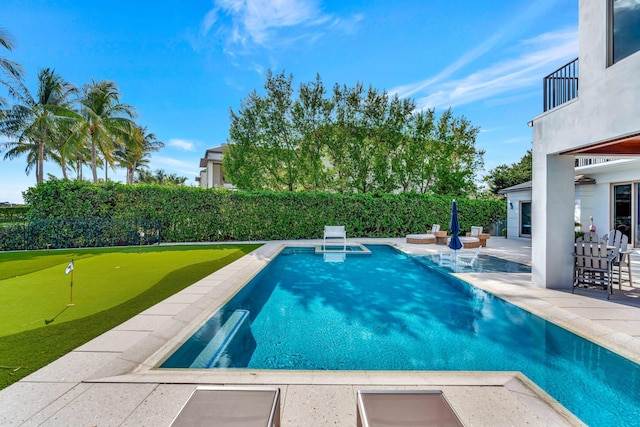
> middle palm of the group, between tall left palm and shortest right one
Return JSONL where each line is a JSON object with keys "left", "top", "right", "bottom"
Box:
{"left": 79, "top": 80, "right": 135, "bottom": 182}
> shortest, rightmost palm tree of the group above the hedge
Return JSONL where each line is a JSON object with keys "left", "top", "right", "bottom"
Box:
{"left": 116, "top": 125, "right": 164, "bottom": 184}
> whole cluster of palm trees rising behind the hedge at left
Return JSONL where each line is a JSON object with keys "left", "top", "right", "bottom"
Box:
{"left": 0, "top": 29, "right": 168, "bottom": 184}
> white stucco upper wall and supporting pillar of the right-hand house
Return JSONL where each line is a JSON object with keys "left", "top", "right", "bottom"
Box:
{"left": 532, "top": 0, "right": 640, "bottom": 288}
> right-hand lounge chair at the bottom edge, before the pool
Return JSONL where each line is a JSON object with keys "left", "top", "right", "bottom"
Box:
{"left": 357, "top": 390, "right": 463, "bottom": 427}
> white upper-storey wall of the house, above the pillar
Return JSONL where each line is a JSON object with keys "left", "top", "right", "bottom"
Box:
{"left": 534, "top": 0, "right": 640, "bottom": 153}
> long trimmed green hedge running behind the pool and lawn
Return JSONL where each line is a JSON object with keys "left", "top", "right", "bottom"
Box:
{"left": 18, "top": 180, "right": 506, "bottom": 246}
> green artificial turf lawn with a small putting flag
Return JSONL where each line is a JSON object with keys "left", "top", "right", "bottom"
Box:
{"left": 0, "top": 245, "right": 259, "bottom": 389}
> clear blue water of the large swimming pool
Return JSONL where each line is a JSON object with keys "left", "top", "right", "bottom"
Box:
{"left": 162, "top": 246, "right": 640, "bottom": 426}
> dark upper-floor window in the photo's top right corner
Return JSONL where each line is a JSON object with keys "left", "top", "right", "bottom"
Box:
{"left": 609, "top": 0, "right": 640, "bottom": 65}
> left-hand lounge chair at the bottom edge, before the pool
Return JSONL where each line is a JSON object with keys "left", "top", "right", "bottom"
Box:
{"left": 171, "top": 386, "right": 280, "bottom": 427}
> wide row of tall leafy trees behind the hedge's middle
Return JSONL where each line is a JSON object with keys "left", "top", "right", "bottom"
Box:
{"left": 223, "top": 71, "right": 484, "bottom": 196}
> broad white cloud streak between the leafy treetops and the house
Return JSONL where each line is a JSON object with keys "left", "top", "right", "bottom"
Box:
{"left": 394, "top": 27, "right": 578, "bottom": 109}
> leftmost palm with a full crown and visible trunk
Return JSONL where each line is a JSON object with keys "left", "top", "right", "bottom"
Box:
{"left": 0, "top": 68, "right": 78, "bottom": 184}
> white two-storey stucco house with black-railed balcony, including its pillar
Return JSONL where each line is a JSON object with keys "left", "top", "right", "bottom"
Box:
{"left": 531, "top": 0, "right": 640, "bottom": 288}
